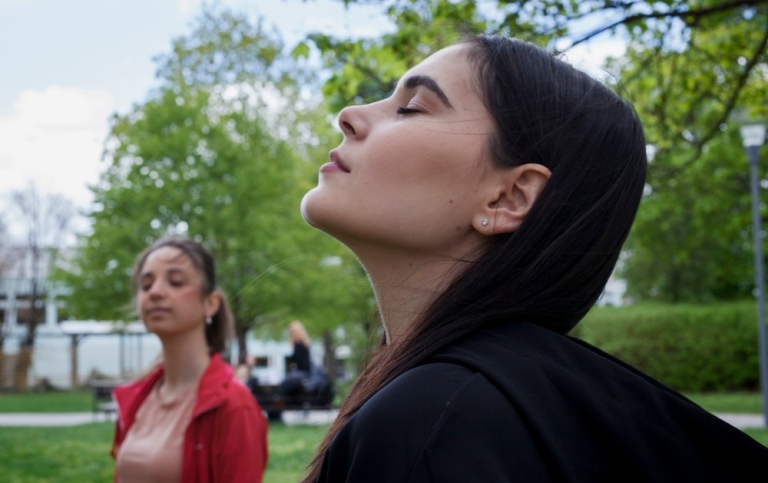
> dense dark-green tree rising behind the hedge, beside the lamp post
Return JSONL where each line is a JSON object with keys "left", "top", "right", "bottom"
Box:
{"left": 622, "top": 128, "right": 754, "bottom": 302}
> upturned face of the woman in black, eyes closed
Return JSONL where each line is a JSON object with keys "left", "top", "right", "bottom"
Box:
{"left": 302, "top": 45, "right": 494, "bottom": 260}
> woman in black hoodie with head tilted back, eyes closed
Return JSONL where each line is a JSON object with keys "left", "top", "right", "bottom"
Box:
{"left": 302, "top": 36, "right": 768, "bottom": 483}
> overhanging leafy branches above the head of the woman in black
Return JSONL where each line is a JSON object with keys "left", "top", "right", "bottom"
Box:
{"left": 320, "top": 0, "right": 768, "bottom": 132}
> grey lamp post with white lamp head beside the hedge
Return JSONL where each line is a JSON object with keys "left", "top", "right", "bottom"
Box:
{"left": 741, "top": 124, "right": 768, "bottom": 425}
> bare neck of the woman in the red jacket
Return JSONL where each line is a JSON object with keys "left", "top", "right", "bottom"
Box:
{"left": 162, "top": 332, "right": 211, "bottom": 391}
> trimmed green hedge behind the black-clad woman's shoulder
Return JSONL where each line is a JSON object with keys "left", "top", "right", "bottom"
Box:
{"left": 571, "top": 301, "right": 759, "bottom": 392}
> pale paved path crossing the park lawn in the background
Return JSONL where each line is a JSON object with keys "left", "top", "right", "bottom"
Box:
{"left": 0, "top": 410, "right": 765, "bottom": 429}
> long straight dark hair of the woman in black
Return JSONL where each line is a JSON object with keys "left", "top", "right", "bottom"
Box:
{"left": 303, "top": 36, "right": 647, "bottom": 482}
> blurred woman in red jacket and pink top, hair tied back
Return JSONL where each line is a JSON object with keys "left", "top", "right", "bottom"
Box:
{"left": 112, "top": 237, "right": 267, "bottom": 483}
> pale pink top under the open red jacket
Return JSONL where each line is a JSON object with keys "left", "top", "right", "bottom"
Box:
{"left": 115, "top": 381, "right": 197, "bottom": 483}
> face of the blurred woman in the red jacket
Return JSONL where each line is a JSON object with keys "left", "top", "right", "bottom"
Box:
{"left": 137, "top": 247, "right": 213, "bottom": 336}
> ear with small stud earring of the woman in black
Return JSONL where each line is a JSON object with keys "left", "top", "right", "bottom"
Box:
{"left": 472, "top": 163, "right": 552, "bottom": 235}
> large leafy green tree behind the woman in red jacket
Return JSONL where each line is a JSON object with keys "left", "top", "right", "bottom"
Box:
{"left": 60, "top": 5, "right": 367, "bottom": 362}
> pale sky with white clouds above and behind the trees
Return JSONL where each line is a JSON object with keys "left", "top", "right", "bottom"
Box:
{"left": 0, "top": 0, "right": 616, "bottom": 236}
